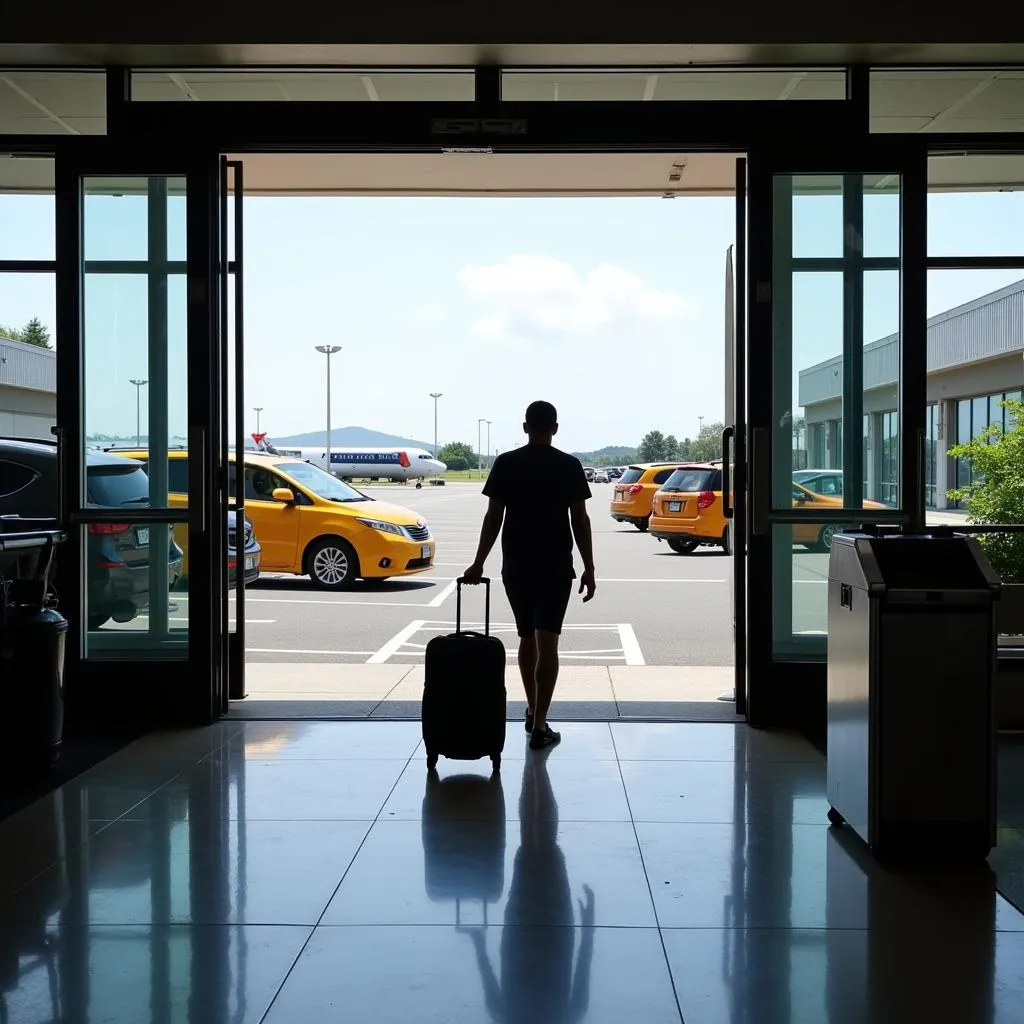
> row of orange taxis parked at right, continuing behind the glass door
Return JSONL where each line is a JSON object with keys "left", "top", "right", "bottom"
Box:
{"left": 610, "top": 461, "right": 886, "bottom": 555}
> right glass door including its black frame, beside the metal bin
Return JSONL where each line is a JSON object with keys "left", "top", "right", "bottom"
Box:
{"left": 748, "top": 148, "right": 925, "bottom": 720}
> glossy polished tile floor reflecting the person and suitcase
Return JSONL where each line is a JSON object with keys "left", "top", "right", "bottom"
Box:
{"left": 0, "top": 722, "right": 1024, "bottom": 1024}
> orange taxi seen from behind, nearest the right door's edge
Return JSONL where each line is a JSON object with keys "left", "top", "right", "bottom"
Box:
{"left": 650, "top": 463, "right": 729, "bottom": 555}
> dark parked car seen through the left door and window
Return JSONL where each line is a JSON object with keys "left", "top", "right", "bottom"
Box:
{"left": 0, "top": 438, "right": 181, "bottom": 630}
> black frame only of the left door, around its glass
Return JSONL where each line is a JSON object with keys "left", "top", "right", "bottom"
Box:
{"left": 55, "top": 138, "right": 226, "bottom": 727}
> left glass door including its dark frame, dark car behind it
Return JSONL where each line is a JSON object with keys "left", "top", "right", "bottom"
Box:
{"left": 57, "top": 155, "right": 222, "bottom": 721}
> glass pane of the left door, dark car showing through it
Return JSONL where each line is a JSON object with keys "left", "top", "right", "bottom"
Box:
{"left": 74, "top": 175, "right": 189, "bottom": 659}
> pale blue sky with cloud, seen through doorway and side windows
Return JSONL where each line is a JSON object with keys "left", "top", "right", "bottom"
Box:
{"left": 0, "top": 193, "right": 1024, "bottom": 450}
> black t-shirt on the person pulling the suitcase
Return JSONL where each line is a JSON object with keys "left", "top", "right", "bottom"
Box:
{"left": 483, "top": 444, "right": 590, "bottom": 580}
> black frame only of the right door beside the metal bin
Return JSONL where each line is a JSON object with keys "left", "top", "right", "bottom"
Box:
{"left": 737, "top": 136, "right": 928, "bottom": 735}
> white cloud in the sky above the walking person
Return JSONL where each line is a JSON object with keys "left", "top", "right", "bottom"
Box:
{"left": 459, "top": 255, "right": 693, "bottom": 338}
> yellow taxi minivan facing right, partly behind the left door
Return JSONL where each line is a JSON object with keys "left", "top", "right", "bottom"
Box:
{"left": 111, "top": 450, "right": 434, "bottom": 590}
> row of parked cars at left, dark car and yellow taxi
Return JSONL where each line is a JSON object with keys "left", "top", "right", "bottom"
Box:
{"left": 0, "top": 437, "right": 434, "bottom": 630}
